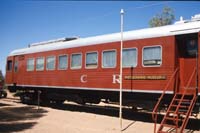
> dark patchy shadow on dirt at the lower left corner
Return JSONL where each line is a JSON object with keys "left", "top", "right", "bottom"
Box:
{"left": 0, "top": 106, "right": 47, "bottom": 133}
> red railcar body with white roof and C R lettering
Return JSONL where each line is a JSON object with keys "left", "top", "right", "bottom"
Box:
{"left": 6, "top": 15, "right": 200, "bottom": 109}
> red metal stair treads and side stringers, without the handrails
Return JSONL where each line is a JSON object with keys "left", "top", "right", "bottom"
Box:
{"left": 157, "top": 93, "right": 196, "bottom": 133}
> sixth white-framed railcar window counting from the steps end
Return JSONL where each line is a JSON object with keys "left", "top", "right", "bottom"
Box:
{"left": 58, "top": 55, "right": 68, "bottom": 70}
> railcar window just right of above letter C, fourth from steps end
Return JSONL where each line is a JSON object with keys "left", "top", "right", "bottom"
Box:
{"left": 86, "top": 52, "right": 98, "bottom": 68}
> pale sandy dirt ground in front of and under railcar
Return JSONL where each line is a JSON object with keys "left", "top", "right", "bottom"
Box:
{"left": 0, "top": 92, "right": 200, "bottom": 133}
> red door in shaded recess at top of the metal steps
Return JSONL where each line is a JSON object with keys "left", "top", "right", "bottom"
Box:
{"left": 176, "top": 33, "right": 198, "bottom": 93}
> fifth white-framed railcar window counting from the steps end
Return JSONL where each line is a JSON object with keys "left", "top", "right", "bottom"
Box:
{"left": 71, "top": 54, "right": 82, "bottom": 69}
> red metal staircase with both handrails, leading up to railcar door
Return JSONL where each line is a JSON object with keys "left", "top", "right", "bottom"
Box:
{"left": 152, "top": 68, "right": 197, "bottom": 133}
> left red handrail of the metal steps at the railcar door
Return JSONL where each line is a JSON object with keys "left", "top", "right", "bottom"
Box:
{"left": 152, "top": 68, "right": 179, "bottom": 133}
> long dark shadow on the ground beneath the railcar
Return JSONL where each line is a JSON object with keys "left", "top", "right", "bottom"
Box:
{"left": 48, "top": 104, "right": 200, "bottom": 133}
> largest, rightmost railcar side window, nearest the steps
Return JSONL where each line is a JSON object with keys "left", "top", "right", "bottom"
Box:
{"left": 143, "top": 46, "right": 162, "bottom": 66}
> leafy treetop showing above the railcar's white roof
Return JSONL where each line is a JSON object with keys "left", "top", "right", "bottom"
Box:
{"left": 149, "top": 7, "right": 175, "bottom": 27}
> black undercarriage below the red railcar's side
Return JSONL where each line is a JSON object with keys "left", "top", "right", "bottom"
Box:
{"left": 9, "top": 87, "right": 200, "bottom": 114}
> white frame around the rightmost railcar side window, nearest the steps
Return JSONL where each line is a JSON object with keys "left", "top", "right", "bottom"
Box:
{"left": 142, "top": 45, "right": 163, "bottom": 67}
